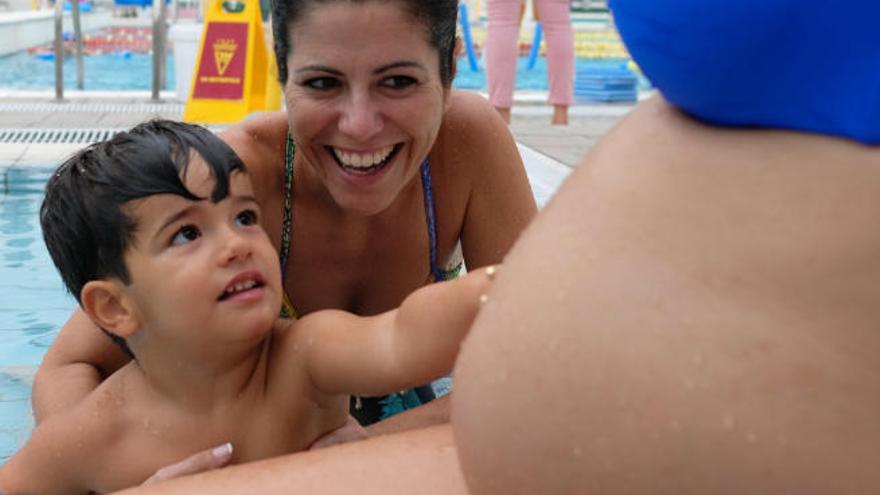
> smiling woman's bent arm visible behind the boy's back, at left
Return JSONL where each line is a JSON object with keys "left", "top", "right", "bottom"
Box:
{"left": 31, "top": 308, "right": 129, "bottom": 424}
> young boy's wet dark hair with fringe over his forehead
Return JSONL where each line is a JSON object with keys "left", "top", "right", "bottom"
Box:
{"left": 40, "top": 120, "right": 245, "bottom": 355}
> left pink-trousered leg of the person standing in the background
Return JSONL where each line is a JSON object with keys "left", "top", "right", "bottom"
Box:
{"left": 486, "top": 0, "right": 520, "bottom": 123}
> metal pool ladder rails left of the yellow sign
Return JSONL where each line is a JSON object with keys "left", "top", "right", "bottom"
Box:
{"left": 55, "top": 0, "right": 168, "bottom": 101}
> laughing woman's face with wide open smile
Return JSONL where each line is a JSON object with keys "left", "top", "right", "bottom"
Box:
{"left": 285, "top": 2, "right": 448, "bottom": 215}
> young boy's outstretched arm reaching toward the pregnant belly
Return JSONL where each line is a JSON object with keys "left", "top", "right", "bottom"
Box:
{"left": 297, "top": 267, "right": 496, "bottom": 395}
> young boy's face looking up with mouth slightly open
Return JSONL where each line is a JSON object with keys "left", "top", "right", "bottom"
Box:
{"left": 124, "top": 154, "right": 282, "bottom": 353}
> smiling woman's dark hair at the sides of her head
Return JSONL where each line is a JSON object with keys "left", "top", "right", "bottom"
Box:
{"left": 272, "top": 0, "right": 458, "bottom": 87}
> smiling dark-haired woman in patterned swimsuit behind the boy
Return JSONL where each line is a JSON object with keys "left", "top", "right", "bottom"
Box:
{"left": 34, "top": 0, "right": 536, "bottom": 484}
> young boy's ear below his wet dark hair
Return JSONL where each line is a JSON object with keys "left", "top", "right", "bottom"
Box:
{"left": 80, "top": 280, "right": 141, "bottom": 339}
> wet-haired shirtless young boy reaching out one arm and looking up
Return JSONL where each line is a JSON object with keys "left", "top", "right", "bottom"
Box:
{"left": 0, "top": 121, "right": 493, "bottom": 494}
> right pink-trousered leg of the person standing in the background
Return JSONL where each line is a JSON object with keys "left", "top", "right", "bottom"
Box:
{"left": 535, "top": 0, "right": 574, "bottom": 125}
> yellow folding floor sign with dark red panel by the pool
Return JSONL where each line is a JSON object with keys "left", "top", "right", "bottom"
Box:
{"left": 183, "top": 0, "right": 281, "bottom": 124}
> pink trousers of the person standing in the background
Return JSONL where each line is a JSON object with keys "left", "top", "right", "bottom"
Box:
{"left": 486, "top": 0, "right": 574, "bottom": 108}
